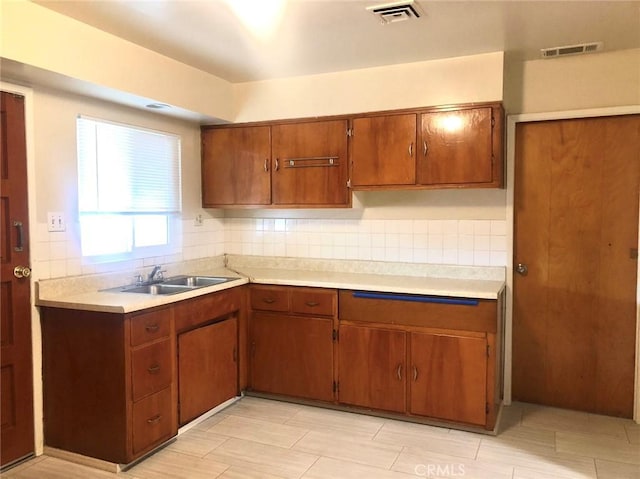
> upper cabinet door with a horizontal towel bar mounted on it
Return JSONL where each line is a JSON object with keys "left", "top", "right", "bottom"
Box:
{"left": 271, "top": 120, "right": 350, "bottom": 206}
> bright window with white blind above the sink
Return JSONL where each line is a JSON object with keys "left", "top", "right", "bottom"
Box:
{"left": 77, "top": 117, "right": 182, "bottom": 262}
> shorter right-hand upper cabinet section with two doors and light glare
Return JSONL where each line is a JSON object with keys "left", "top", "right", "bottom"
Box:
{"left": 351, "top": 103, "right": 504, "bottom": 190}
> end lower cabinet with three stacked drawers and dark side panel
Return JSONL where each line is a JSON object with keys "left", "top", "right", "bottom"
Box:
{"left": 41, "top": 308, "right": 178, "bottom": 464}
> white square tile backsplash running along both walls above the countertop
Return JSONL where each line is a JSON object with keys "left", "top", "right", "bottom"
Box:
{"left": 31, "top": 218, "right": 507, "bottom": 279}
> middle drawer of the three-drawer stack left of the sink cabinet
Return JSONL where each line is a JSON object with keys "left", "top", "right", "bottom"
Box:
{"left": 131, "top": 339, "right": 172, "bottom": 401}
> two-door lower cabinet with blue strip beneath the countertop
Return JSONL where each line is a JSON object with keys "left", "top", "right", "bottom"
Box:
{"left": 337, "top": 290, "right": 502, "bottom": 429}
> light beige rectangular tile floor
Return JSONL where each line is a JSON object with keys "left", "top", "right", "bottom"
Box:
{"left": 2, "top": 397, "right": 640, "bottom": 479}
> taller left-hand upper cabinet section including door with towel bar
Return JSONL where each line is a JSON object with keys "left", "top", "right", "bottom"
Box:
{"left": 202, "top": 119, "right": 351, "bottom": 208}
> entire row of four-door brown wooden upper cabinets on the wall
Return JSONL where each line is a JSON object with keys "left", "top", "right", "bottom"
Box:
{"left": 202, "top": 102, "right": 504, "bottom": 208}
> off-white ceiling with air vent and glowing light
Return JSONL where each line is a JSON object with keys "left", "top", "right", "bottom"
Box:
{"left": 36, "top": 0, "right": 640, "bottom": 82}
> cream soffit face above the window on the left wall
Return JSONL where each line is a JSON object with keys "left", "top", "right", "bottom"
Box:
{"left": 0, "top": 0, "right": 233, "bottom": 120}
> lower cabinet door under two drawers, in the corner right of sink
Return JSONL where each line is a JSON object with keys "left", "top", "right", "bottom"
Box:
{"left": 249, "top": 313, "right": 333, "bottom": 401}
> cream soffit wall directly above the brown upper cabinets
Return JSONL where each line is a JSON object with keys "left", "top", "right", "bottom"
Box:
{"left": 234, "top": 52, "right": 503, "bottom": 122}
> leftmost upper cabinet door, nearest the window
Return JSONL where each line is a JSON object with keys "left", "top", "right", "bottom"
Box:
{"left": 202, "top": 126, "right": 271, "bottom": 207}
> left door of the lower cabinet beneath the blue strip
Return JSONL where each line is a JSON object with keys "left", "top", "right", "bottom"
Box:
{"left": 338, "top": 325, "right": 406, "bottom": 412}
